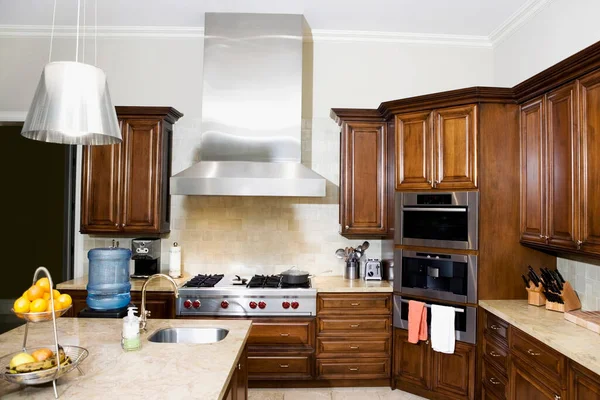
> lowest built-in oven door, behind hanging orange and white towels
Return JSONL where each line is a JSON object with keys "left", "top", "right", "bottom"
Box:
{"left": 394, "top": 295, "right": 477, "bottom": 344}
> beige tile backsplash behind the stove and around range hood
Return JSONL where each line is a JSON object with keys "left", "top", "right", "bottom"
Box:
{"left": 83, "top": 118, "right": 381, "bottom": 275}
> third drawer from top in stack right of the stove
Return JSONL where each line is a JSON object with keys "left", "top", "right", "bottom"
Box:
{"left": 317, "top": 337, "right": 390, "bottom": 357}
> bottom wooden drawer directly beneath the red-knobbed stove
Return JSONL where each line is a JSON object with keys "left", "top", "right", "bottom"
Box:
{"left": 247, "top": 354, "right": 312, "bottom": 379}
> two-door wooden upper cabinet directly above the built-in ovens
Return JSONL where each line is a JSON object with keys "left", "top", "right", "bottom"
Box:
{"left": 395, "top": 105, "right": 477, "bottom": 190}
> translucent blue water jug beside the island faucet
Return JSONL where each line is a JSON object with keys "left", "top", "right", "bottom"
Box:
{"left": 85, "top": 247, "right": 131, "bottom": 310}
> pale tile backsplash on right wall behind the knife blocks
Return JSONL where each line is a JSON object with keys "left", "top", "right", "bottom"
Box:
{"left": 556, "top": 258, "right": 600, "bottom": 311}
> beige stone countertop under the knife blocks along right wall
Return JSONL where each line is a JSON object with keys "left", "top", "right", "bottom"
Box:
{"left": 479, "top": 300, "right": 600, "bottom": 374}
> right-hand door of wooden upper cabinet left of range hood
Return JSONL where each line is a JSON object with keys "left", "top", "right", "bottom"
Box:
{"left": 123, "top": 119, "right": 162, "bottom": 232}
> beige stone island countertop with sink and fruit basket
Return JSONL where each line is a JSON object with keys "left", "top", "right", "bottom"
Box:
{"left": 0, "top": 318, "right": 252, "bottom": 400}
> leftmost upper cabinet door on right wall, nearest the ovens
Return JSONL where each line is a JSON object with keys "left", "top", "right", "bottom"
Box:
{"left": 521, "top": 97, "right": 546, "bottom": 243}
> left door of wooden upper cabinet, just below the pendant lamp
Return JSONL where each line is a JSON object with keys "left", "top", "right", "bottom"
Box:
{"left": 81, "top": 138, "right": 122, "bottom": 233}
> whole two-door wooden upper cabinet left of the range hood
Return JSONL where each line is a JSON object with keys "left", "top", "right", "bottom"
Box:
{"left": 81, "top": 107, "right": 183, "bottom": 234}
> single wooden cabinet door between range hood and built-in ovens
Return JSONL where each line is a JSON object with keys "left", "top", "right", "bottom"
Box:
{"left": 340, "top": 121, "right": 389, "bottom": 237}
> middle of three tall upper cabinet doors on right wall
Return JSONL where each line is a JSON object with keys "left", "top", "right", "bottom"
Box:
{"left": 546, "top": 84, "right": 578, "bottom": 248}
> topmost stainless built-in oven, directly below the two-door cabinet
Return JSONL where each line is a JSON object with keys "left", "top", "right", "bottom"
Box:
{"left": 396, "top": 192, "right": 479, "bottom": 250}
